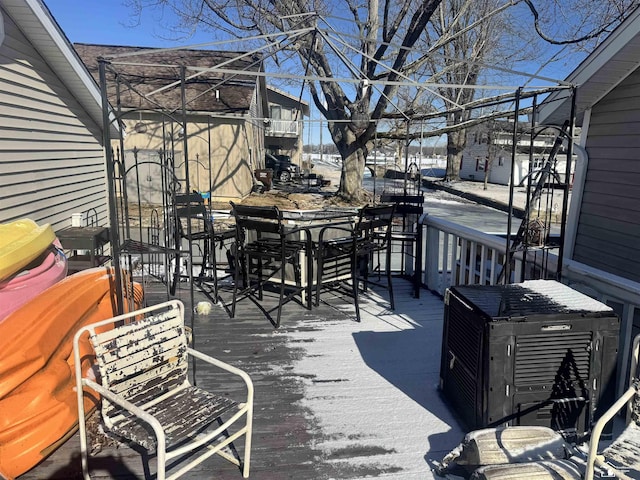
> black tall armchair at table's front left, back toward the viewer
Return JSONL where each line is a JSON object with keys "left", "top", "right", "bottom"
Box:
{"left": 230, "top": 202, "right": 313, "bottom": 328}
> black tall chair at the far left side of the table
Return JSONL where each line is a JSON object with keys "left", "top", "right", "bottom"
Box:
{"left": 170, "top": 192, "right": 235, "bottom": 301}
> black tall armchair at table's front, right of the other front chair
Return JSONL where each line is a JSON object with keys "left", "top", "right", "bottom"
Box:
{"left": 315, "top": 205, "right": 395, "bottom": 321}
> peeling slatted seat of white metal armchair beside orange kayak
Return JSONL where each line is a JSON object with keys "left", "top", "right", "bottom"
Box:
{"left": 111, "top": 386, "right": 238, "bottom": 451}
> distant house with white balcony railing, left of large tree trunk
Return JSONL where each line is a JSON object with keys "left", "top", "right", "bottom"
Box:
{"left": 265, "top": 87, "right": 309, "bottom": 169}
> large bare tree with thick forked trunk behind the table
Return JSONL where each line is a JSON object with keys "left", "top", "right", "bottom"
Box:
{"left": 129, "top": 0, "right": 441, "bottom": 201}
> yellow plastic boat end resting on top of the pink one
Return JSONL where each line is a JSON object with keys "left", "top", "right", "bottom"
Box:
{"left": 0, "top": 218, "right": 56, "bottom": 281}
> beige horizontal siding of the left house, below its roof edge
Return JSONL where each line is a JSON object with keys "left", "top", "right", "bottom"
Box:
{"left": 0, "top": 11, "right": 108, "bottom": 231}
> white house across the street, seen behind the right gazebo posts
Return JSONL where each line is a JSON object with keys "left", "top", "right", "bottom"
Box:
{"left": 460, "top": 121, "right": 567, "bottom": 186}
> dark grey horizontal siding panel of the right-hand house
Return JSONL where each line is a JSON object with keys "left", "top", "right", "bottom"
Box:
{"left": 573, "top": 63, "right": 640, "bottom": 282}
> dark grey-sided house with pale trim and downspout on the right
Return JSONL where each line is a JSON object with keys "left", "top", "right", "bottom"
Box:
{"left": 540, "top": 2, "right": 640, "bottom": 378}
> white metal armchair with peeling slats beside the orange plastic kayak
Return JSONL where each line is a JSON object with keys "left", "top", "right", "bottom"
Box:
{"left": 74, "top": 300, "right": 253, "bottom": 480}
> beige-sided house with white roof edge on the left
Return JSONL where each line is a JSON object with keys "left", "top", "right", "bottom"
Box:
{"left": 0, "top": 0, "right": 115, "bottom": 231}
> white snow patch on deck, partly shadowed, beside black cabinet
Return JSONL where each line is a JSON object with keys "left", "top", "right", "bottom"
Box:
{"left": 276, "top": 279, "right": 463, "bottom": 480}
